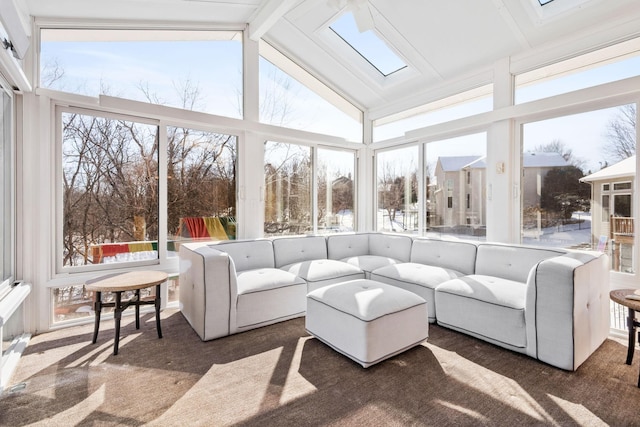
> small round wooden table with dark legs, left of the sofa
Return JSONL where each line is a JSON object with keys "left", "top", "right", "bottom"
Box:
{"left": 85, "top": 271, "right": 169, "bottom": 356}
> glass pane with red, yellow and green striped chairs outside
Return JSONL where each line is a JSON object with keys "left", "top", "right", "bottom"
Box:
{"left": 167, "top": 127, "right": 237, "bottom": 256}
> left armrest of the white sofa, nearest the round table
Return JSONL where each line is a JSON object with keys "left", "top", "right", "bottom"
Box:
{"left": 179, "top": 244, "right": 237, "bottom": 341}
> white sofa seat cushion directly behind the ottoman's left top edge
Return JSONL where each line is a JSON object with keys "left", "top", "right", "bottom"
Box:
{"left": 280, "top": 259, "right": 364, "bottom": 292}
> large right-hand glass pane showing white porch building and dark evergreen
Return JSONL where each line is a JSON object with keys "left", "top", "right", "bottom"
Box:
{"left": 522, "top": 105, "right": 635, "bottom": 272}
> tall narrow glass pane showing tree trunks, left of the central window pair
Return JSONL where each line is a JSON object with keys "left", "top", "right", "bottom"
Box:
{"left": 264, "top": 141, "right": 312, "bottom": 236}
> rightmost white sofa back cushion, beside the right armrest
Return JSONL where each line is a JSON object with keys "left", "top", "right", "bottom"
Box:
{"left": 476, "top": 243, "right": 566, "bottom": 283}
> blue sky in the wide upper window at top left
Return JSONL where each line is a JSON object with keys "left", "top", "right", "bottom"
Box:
{"left": 41, "top": 41, "right": 242, "bottom": 118}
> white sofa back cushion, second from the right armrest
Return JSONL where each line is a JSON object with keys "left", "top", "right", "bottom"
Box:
{"left": 411, "top": 239, "right": 477, "bottom": 274}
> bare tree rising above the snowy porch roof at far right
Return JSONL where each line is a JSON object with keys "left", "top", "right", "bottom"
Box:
{"left": 602, "top": 104, "right": 637, "bottom": 163}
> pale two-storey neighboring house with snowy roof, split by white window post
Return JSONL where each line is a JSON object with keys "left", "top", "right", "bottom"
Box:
{"left": 436, "top": 153, "right": 569, "bottom": 227}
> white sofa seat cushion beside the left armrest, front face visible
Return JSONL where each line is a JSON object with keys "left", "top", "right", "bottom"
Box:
{"left": 236, "top": 268, "right": 307, "bottom": 330}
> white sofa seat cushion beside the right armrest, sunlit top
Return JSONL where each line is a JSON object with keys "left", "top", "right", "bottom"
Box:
{"left": 435, "top": 275, "right": 527, "bottom": 351}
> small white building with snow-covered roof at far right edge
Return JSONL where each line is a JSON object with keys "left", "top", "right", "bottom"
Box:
{"left": 580, "top": 156, "right": 636, "bottom": 251}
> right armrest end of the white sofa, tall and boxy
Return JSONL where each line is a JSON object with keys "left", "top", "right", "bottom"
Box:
{"left": 525, "top": 252, "right": 609, "bottom": 371}
